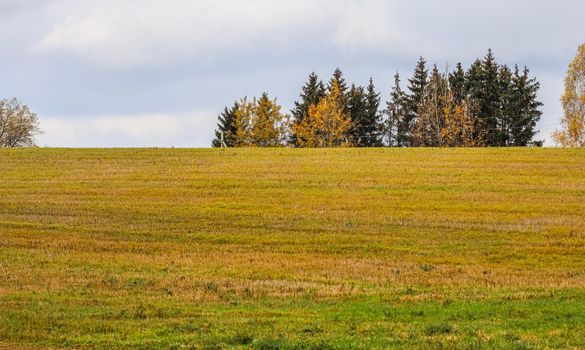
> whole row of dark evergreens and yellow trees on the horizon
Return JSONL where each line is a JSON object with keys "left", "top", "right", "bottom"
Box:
{"left": 212, "top": 50, "right": 542, "bottom": 147}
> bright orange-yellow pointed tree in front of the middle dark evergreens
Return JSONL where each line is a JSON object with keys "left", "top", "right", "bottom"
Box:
{"left": 292, "top": 80, "right": 352, "bottom": 148}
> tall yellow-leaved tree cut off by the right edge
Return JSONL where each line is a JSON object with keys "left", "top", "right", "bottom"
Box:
{"left": 552, "top": 44, "right": 585, "bottom": 147}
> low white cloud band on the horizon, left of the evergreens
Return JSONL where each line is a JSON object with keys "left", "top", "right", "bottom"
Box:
{"left": 39, "top": 112, "right": 215, "bottom": 147}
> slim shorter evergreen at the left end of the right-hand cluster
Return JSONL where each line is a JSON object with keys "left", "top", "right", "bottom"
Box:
{"left": 384, "top": 73, "right": 409, "bottom": 147}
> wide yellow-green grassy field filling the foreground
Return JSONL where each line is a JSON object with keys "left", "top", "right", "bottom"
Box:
{"left": 0, "top": 149, "right": 585, "bottom": 349}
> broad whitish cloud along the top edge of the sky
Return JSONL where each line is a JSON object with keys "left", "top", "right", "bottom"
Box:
{"left": 33, "top": 0, "right": 342, "bottom": 67}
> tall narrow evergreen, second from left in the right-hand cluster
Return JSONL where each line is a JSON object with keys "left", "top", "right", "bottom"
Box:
{"left": 404, "top": 57, "right": 428, "bottom": 146}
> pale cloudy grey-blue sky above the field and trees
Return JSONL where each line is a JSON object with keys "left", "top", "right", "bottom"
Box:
{"left": 0, "top": 0, "right": 585, "bottom": 147}
